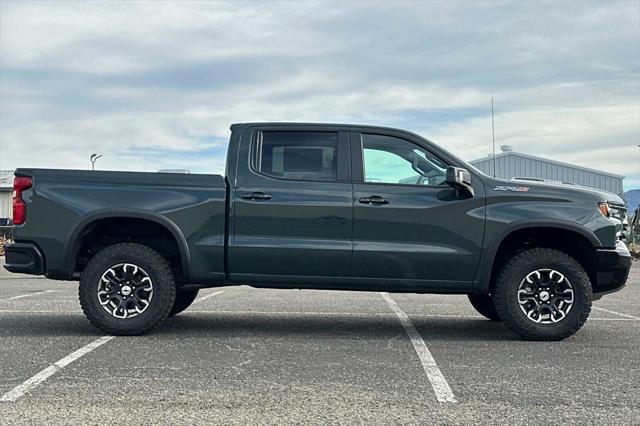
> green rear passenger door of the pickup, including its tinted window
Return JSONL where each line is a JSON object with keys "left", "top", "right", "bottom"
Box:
{"left": 229, "top": 126, "right": 353, "bottom": 281}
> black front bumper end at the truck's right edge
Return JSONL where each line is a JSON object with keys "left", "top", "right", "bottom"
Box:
{"left": 593, "top": 241, "right": 631, "bottom": 299}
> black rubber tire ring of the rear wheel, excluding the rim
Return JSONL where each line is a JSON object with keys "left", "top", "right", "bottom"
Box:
{"left": 79, "top": 243, "right": 176, "bottom": 336}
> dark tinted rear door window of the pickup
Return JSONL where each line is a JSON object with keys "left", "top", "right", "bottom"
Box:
{"left": 253, "top": 131, "right": 338, "bottom": 181}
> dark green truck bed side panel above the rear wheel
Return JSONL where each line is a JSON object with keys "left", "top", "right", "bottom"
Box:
{"left": 11, "top": 169, "right": 227, "bottom": 282}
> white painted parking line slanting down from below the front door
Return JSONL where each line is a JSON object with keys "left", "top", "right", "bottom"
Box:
{"left": 380, "top": 293, "right": 457, "bottom": 402}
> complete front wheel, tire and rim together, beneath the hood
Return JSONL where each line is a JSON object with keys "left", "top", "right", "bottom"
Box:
{"left": 493, "top": 248, "right": 593, "bottom": 340}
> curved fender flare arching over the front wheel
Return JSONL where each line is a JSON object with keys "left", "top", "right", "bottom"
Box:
{"left": 476, "top": 219, "right": 602, "bottom": 294}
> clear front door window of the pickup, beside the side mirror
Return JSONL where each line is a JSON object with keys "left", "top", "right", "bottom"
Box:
{"left": 362, "top": 133, "right": 447, "bottom": 186}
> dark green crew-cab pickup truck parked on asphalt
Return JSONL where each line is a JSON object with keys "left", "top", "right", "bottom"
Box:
{"left": 5, "top": 123, "right": 631, "bottom": 340}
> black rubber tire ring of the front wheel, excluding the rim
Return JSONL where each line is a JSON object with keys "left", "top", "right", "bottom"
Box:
{"left": 493, "top": 248, "right": 593, "bottom": 341}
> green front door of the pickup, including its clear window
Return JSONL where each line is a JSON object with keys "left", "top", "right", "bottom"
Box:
{"left": 351, "top": 131, "right": 484, "bottom": 290}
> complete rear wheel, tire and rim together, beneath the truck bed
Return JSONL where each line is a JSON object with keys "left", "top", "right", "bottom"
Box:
{"left": 79, "top": 243, "right": 176, "bottom": 335}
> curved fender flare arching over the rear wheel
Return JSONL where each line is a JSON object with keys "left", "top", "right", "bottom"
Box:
{"left": 63, "top": 208, "right": 191, "bottom": 280}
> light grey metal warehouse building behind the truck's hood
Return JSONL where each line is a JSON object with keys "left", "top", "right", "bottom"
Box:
{"left": 470, "top": 145, "right": 624, "bottom": 195}
